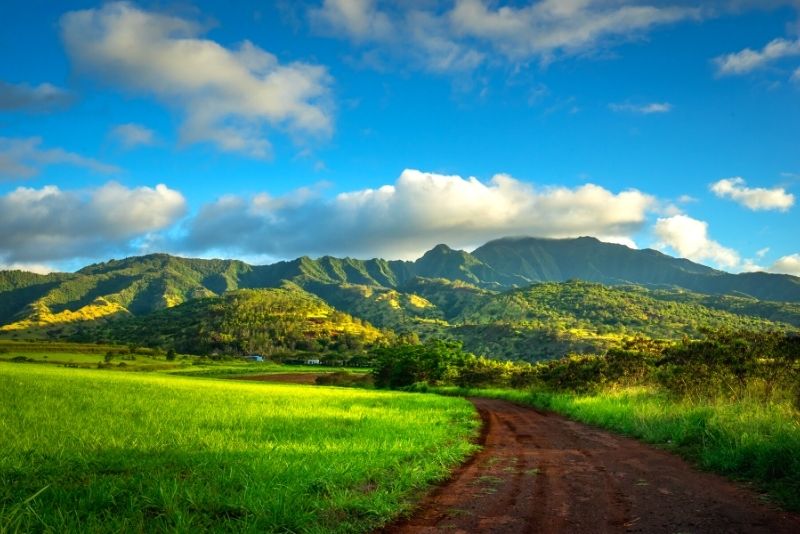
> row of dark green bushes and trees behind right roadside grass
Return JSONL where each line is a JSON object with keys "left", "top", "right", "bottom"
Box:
{"left": 373, "top": 330, "right": 800, "bottom": 408}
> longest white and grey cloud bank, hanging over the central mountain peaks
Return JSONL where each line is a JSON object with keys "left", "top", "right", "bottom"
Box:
{"left": 183, "top": 170, "right": 656, "bottom": 258}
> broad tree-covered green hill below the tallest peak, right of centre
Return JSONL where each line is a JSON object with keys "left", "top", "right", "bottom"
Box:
{"left": 451, "top": 281, "right": 800, "bottom": 361}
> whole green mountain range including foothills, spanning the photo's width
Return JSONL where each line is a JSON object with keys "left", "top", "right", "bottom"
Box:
{"left": 0, "top": 237, "right": 800, "bottom": 359}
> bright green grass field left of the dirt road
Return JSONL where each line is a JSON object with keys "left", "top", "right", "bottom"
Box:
{"left": 0, "top": 362, "right": 478, "bottom": 532}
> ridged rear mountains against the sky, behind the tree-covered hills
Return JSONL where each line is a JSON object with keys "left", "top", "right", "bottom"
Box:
{"left": 0, "top": 237, "right": 800, "bottom": 330}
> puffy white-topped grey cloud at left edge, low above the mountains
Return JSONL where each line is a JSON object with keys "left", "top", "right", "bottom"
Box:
{"left": 0, "top": 182, "right": 186, "bottom": 265}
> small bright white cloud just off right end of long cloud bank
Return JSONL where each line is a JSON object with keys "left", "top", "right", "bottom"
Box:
{"left": 654, "top": 215, "right": 740, "bottom": 268}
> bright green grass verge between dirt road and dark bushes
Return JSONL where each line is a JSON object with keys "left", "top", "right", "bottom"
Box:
{"left": 430, "top": 386, "right": 800, "bottom": 511}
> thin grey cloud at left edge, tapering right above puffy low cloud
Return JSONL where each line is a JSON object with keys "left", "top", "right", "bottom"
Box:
{"left": 0, "top": 137, "right": 120, "bottom": 181}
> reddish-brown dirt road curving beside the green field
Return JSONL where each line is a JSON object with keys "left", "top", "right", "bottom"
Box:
{"left": 384, "top": 398, "right": 800, "bottom": 534}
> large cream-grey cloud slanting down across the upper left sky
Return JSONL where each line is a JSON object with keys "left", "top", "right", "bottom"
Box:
{"left": 61, "top": 2, "right": 332, "bottom": 158}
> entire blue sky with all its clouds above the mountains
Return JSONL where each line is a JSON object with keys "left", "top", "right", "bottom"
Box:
{"left": 0, "top": 0, "right": 800, "bottom": 275}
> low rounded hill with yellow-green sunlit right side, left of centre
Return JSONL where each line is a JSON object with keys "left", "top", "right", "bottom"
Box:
{"left": 86, "top": 288, "right": 391, "bottom": 355}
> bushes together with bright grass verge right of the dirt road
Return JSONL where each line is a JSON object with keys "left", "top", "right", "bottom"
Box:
{"left": 374, "top": 331, "right": 800, "bottom": 510}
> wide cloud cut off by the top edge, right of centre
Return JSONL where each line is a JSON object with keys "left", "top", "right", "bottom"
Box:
{"left": 309, "top": 0, "right": 701, "bottom": 71}
